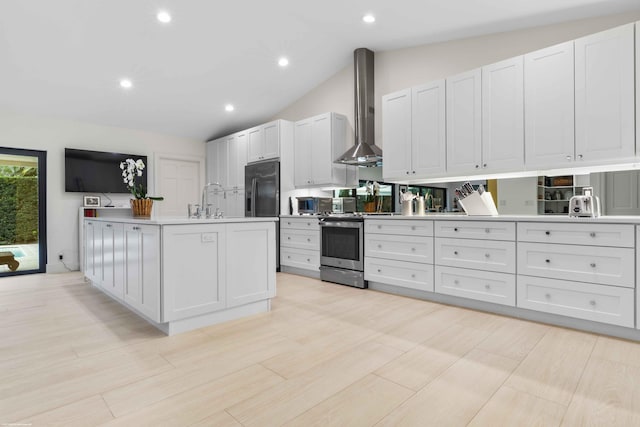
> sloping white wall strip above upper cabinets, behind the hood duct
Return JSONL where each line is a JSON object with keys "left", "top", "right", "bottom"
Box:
{"left": 274, "top": 9, "right": 640, "bottom": 156}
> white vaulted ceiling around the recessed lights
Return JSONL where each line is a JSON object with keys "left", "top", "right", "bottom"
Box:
{"left": 0, "top": 0, "right": 639, "bottom": 140}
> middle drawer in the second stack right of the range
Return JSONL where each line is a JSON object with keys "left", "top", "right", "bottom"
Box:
{"left": 435, "top": 238, "right": 516, "bottom": 273}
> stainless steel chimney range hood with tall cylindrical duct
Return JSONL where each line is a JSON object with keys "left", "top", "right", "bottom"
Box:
{"left": 335, "top": 48, "right": 382, "bottom": 167}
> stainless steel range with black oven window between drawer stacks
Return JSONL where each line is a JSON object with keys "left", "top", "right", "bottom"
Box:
{"left": 320, "top": 214, "right": 367, "bottom": 288}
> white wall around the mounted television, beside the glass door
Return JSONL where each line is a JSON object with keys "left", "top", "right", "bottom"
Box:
{"left": 0, "top": 111, "right": 205, "bottom": 272}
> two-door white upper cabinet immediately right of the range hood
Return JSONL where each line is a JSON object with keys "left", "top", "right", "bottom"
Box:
{"left": 382, "top": 80, "right": 446, "bottom": 180}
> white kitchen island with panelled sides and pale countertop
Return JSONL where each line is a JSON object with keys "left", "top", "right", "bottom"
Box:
{"left": 82, "top": 217, "right": 278, "bottom": 335}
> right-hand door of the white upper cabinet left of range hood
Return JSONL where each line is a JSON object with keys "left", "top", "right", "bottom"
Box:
{"left": 309, "top": 113, "right": 336, "bottom": 185}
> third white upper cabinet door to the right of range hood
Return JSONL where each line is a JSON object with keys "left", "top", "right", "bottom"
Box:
{"left": 447, "top": 69, "right": 482, "bottom": 174}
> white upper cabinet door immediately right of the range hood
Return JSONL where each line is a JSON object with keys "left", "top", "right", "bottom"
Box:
{"left": 382, "top": 89, "right": 412, "bottom": 179}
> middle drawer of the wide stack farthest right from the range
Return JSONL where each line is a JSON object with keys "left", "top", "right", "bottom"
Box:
{"left": 518, "top": 243, "right": 635, "bottom": 288}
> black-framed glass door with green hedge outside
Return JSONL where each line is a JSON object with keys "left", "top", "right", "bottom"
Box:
{"left": 0, "top": 147, "right": 47, "bottom": 277}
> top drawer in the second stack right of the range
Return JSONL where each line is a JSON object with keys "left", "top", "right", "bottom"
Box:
{"left": 435, "top": 220, "right": 516, "bottom": 240}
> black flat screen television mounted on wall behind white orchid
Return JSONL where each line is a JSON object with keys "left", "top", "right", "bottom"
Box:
{"left": 64, "top": 148, "right": 147, "bottom": 193}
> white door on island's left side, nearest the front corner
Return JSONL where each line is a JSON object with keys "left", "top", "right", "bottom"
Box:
{"left": 124, "top": 224, "right": 160, "bottom": 322}
